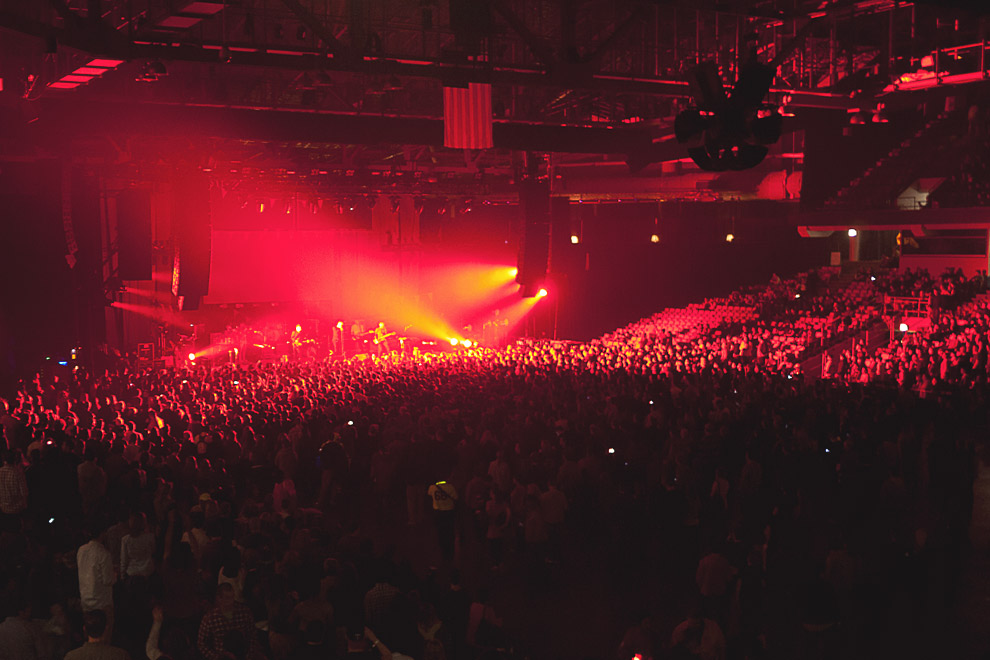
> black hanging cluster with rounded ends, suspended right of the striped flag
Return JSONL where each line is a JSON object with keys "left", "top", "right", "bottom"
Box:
{"left": 674, "top": 59, "right": 783, "bottom": 172}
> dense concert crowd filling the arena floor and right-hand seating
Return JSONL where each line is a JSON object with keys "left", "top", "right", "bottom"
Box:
{"left": 0, "top": 270, "right": 990, "bottom": 660}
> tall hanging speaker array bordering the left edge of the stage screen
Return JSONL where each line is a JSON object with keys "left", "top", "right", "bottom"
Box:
{"left": 172, "top": 177, "right": 212, "bottom": 299}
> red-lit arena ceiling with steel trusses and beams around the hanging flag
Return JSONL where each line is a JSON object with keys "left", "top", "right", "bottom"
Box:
{"left": 0, "top": 0, "right": 986, "bottom": 197}
